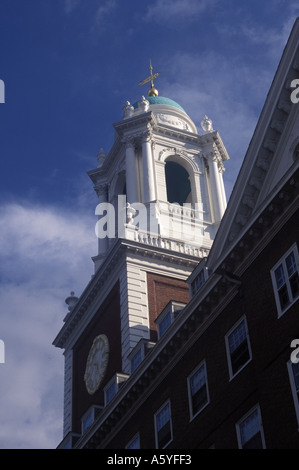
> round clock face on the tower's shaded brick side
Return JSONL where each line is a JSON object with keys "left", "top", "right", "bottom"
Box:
{"left": 84, "top": 335, "right": 109, "bottom": 395}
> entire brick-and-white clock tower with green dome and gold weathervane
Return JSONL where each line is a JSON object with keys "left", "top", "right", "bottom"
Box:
{"left": 54, "top": 64, "right": 229, "bottom": 442}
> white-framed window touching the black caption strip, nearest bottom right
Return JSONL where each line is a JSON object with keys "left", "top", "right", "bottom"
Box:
{"left": 237, "top": 407, "right": 265, "bottom": 449}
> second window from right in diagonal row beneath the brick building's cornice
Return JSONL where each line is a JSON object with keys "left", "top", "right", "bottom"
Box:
{"left": 225, "top": 318, "right": 251, "bottom": 378}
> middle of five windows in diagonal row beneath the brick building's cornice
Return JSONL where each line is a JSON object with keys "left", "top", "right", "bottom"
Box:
{"left": 187, "top": 363, "right": 209, "bottom": 419}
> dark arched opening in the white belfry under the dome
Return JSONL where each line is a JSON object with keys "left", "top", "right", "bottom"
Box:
{"left": 165, "top": 161, "right": 192, "bottom": 206}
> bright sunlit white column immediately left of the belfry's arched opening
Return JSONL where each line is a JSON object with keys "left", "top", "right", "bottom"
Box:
{"left": 142, "top": 132, "right": 156, "bottom": 203}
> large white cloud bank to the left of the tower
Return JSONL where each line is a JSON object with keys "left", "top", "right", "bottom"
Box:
{"left": 0, "top": 203, "right": 96, "bottom": 449}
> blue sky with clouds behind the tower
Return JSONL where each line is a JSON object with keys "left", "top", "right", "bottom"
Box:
{"left": 0, "top": 0, "right": 299, "bottom": 449}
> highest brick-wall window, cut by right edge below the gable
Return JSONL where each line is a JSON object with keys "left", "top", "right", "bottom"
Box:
{"left": 271, "top": 245, "right": 299, "bottom": 316}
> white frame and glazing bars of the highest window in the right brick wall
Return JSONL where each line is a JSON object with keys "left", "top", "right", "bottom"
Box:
{"left": 271, "top": 243, "right": 299, "bottom": 318}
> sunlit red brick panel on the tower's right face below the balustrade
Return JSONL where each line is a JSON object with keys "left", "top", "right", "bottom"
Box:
{"left": 147, "top": 273, "right": 189, "bottom": 341}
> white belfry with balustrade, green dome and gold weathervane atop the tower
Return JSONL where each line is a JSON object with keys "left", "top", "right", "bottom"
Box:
{"left": 89, "top": 65, "right": 229, "bottom": 269}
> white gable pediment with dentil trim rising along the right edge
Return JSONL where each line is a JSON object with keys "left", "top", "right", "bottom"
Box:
{"left": 207, "top": 18, "right": 299, "bottom": 271}
